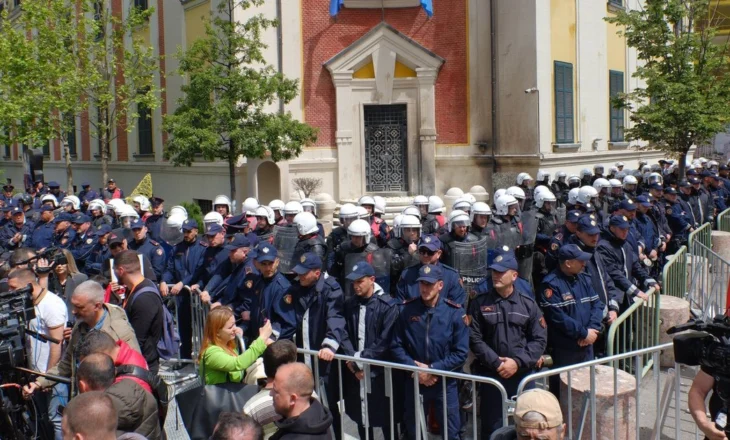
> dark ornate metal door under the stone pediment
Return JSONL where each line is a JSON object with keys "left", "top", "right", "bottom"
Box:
{"left": 365, "top": 104, "right": 408, "bottom": 192}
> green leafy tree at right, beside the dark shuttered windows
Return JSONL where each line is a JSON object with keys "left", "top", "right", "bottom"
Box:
{"left": 606, "top": 0, "right": 730, "bottom": 178}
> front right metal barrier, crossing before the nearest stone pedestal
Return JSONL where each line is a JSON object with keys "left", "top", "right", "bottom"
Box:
{"left": 510, "top": 343, "right": 699, "bottom": 440}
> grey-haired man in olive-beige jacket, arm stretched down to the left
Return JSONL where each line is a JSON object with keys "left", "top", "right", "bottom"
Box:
{"left": 23, "top": 281, "right": 140, "bottom": 397}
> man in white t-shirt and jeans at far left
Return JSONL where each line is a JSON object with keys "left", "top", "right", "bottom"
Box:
{"left": 8, "top": 268, "right": 68, "bottom": 439}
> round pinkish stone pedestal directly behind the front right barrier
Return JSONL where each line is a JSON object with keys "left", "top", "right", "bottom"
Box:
{"left": 560, "top": 365, "right": 637, "bottom": 440}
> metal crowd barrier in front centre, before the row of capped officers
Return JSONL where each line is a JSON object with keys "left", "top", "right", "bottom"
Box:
{"left": 297, "top": 348, "right": 510, "bottom": 440}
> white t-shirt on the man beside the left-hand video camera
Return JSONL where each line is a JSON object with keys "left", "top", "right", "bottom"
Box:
{"left": 26, "top": 292, "right": 68, "bottom": 373}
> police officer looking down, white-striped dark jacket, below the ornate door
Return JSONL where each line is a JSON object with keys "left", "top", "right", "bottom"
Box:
{"left": 344, "top": 263, "right": 398, "bottom": 439}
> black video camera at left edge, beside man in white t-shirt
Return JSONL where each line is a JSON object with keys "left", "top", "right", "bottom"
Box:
{"left": 0, "top": 284, "right": 35, "bottom": 369}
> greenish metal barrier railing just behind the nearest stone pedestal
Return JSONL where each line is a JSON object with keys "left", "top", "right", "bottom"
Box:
{"left": 607, "top": 288, "right": 661, "bottom": 375}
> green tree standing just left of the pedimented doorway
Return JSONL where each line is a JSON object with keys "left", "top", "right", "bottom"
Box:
{"left": 164, "top": 0, "right": 316, "bottom": 200}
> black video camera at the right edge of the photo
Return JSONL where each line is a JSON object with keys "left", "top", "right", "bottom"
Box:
{"left": 667, "top": 316, "right": 730, "bottom": 437}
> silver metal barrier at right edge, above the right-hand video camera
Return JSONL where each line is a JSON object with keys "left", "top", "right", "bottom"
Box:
{"left": 687, "top": 240, "right": 730, "bottom": 319}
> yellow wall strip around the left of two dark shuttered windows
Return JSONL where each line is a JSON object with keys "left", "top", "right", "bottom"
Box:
{"left": 550, "top": 0, "right": 581, "bottom": 142}
